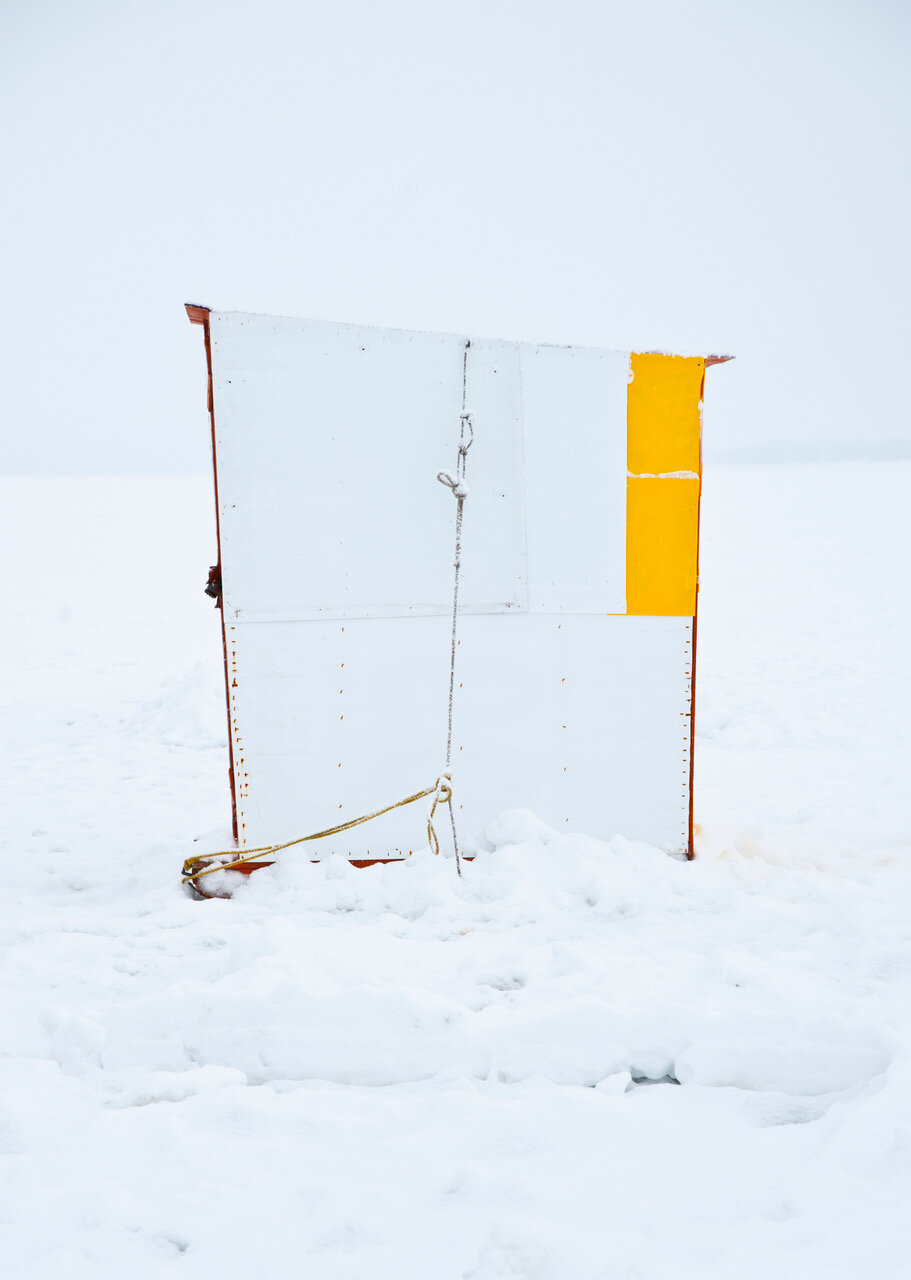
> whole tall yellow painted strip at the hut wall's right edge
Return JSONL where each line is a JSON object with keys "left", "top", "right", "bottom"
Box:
{"left": 627, "top": 355, "right": 705, "bottom": 617}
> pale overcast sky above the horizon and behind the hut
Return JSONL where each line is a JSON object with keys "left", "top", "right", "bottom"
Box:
{"left": 0, "top": 0, "right": 911, "bottom": 472}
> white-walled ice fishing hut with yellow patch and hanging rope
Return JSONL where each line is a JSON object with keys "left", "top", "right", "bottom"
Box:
{"left": 187, "top": 306, "right": 728, "bottom": 890}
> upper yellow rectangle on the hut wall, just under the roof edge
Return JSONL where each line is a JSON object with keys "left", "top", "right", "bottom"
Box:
{"left": 627, "top": 353, "right": 705, "bottom": 475}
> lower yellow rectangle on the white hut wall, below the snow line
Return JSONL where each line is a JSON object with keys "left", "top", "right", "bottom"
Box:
{"left": 627, "top": 476, "right": 701, "bottom": 617}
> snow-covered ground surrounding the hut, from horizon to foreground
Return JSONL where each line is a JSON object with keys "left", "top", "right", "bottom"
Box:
{"left": 0, "top": 462, "right": 911, "bottom": 1280}
